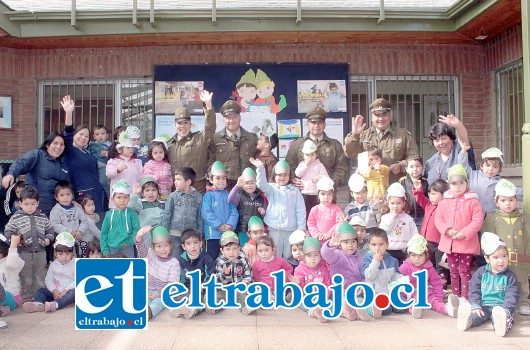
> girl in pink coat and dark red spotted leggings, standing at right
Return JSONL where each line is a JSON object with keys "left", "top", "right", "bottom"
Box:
{"left": 435, "top": 164, "right": 484, "bottom": 299}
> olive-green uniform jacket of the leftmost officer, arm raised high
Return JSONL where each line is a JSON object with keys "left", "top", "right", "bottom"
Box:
{"left": 167, "top": 108, "right": 216, "bottom": 192}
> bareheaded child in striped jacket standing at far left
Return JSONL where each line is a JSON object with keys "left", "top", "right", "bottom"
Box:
{"left": 4, "top": 187, "right": 54, "bottom": 299}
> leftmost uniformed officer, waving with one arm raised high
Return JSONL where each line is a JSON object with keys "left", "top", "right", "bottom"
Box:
{"left": 167, "top": 90, "right": 216, "bottom": 193}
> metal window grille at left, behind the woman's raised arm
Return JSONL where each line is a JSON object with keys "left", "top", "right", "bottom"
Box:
{"left": 38, "top": 79, "right": 153, "bottom": 143}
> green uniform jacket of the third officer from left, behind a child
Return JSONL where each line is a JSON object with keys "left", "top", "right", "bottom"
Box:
{"left": 285, "top": 133, "right": 348, "bottom": 188}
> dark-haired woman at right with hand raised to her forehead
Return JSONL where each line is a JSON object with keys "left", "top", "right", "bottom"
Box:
{"left": 425, "top": 114, "right": 475, "bottom": 185}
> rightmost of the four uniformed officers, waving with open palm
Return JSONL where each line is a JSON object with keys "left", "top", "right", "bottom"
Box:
{"left": 344, "top": 98, "right": 418, "bottom": 183}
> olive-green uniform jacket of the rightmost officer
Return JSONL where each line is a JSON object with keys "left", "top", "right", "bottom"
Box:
{"left": 344, "top": 124, "right": 419, "bottom": 183}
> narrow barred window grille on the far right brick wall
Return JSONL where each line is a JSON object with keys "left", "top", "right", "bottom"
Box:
{"left": 495, "top": 61, "right": 524, "bottom": 166}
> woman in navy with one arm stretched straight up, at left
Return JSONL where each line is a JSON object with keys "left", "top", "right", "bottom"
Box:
{"left": 61, "top": 96, "right": 106, "bottom": 213}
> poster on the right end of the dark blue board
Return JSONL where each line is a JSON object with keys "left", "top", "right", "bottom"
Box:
{"left": 297, "top": 80, "right": 347, "bottom": 113}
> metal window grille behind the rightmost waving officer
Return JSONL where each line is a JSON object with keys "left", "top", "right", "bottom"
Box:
{"left": 350, "top": 74, "right": 460, "bottom": 159}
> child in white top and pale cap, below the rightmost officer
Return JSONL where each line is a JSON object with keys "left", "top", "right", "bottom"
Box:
{"left": 379, "top": 182, "right": 418, "bottom": 264}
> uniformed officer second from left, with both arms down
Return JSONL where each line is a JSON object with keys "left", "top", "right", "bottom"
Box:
{"left": 208, "top": 100, "right": 258, "bottom": 191}
